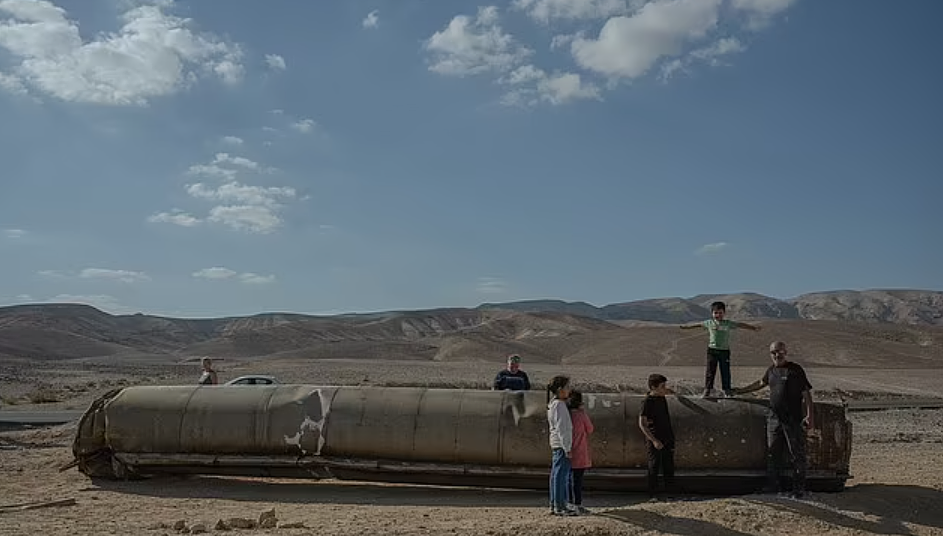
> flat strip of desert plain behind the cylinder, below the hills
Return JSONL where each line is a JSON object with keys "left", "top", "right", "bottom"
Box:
{"left": 0, "top": 359, "right": 943, "bottom": 411}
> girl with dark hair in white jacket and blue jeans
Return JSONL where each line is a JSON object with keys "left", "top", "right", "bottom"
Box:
{"left": 547, "top": 376, "right": 578, "bottom": 516}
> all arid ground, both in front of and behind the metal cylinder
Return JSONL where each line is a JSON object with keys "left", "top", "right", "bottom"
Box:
{"left": 0, "top": 360, "right": 943, "bottom": 536}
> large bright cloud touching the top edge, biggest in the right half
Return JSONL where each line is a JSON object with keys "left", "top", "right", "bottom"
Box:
{"left": 570, "top": 0, "right": 722, "bottom": 79}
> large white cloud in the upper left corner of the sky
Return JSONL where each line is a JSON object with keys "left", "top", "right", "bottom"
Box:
{"left": 0, "top": 0, "right": 244, "bottom": 106}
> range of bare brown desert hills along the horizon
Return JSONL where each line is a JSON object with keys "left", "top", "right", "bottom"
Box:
{"left": 0, "top": 290, "right": 943, "bottom": 368}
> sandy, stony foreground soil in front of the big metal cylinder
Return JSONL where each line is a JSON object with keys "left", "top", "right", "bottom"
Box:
{"left": 0, "top": 410, "right": 943, "bottom": 536}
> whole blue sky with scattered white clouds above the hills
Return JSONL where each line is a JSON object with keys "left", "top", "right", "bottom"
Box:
{"left": 0, "top": 0, "right": 943, "bottom": 317}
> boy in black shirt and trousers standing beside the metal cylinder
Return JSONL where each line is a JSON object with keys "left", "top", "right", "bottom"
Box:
{"left": 638, "top": 374, "right": 675, "bottom": 499}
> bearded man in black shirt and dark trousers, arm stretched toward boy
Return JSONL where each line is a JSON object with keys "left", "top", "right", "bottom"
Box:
{"left": 735, "top": 341, "right": 815, "bottom": 498}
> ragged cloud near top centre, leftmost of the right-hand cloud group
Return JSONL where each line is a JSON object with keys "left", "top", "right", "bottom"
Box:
{"left": 424, "top": 6, "right": 533, "bottom": 77}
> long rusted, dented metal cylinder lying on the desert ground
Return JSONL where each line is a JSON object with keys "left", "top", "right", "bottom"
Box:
{"left": 73, "top": 385, "right": 851, "bottom": 490}
